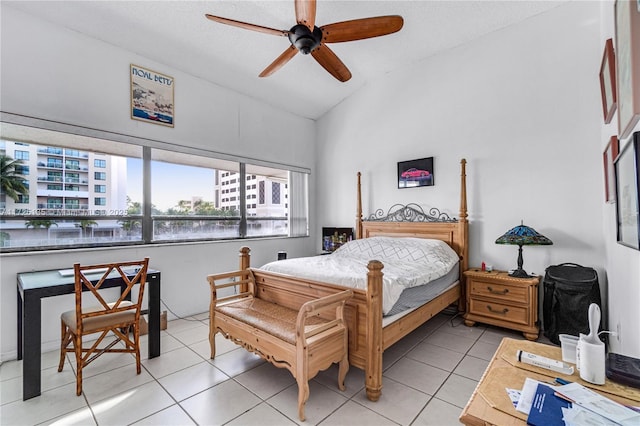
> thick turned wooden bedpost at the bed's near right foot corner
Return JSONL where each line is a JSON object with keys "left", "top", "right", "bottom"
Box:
{"left": 364, "top": 260, "right": 384, "bottom": 401}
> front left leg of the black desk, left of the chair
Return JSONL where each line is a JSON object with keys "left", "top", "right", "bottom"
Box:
{"left": 22, "top": 292, "right": 42, "bottom": 400}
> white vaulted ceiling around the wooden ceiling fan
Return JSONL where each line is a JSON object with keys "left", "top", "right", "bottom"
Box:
{"left": 1, "top": 0, "right": 567, "bottom": 119}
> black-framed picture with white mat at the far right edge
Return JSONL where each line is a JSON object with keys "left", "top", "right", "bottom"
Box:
{"left": 615, "top": 132, "right": 640, "bottom": 250}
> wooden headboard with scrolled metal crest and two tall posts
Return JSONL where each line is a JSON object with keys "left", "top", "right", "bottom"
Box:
{"left": 356, "top": 158, "right": 469, "bottom": 306}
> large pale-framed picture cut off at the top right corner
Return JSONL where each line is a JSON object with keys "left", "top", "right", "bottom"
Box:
{"left": 614, "top": 0, "right": 640, "bottom": 140}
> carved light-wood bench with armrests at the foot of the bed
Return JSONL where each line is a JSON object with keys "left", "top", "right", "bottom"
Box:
{"left": 207, "top": 268, "right": 353, "bottom": 421}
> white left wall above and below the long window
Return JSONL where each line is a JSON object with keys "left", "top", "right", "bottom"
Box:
{"left": 0, "top": 5, "right": 317, "bottom": 360}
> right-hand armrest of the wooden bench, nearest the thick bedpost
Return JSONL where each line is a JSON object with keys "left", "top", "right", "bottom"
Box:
{"left": 296, "top": 290, "right": 353, "bottom": 343}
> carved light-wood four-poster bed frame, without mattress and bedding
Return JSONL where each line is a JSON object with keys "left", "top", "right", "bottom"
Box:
{"left": 240, "top": 159, "right": 468, "bottom": 401}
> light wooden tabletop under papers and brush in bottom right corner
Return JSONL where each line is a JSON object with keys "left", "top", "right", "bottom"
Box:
{"left": 460, "top": 338, "right": 640, "bottom": 426}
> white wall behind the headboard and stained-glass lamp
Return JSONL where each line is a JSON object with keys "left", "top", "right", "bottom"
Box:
{"left": 317, "top": 2, "right": 640, "bottom": 356}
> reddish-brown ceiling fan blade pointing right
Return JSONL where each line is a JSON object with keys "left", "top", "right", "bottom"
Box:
{"left": 320, "top": 15, "right": 404, "bottom": 43}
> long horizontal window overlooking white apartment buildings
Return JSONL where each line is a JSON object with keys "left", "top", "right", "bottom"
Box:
{"left": 0, "top": 120, "right": 308, "bottom": 251}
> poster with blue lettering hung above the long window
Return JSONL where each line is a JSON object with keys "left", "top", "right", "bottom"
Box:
{"left": 130, "top": 64, "right": 174, "bottom": 127}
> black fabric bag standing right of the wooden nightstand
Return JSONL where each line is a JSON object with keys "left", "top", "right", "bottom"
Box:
{"left": 542, "top": 263, "right": 602, "bottom": 345}
